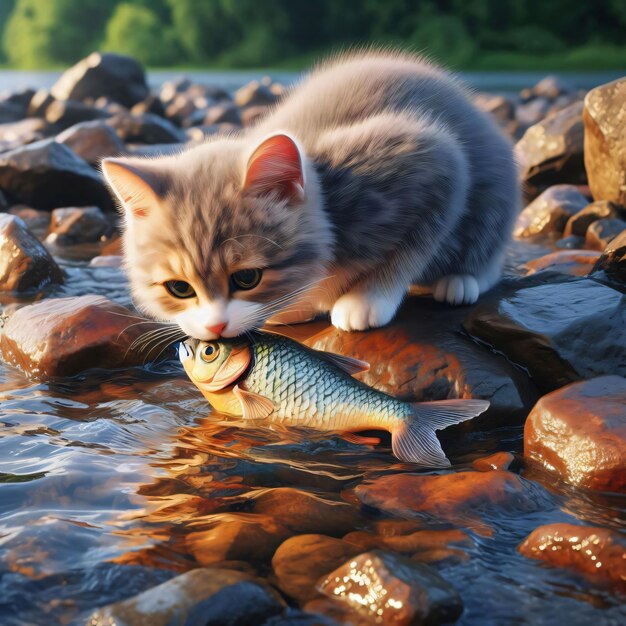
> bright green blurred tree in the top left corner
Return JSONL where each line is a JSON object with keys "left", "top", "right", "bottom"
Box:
{"left": 3, "top": 0, "right": 117, "bottom": 68}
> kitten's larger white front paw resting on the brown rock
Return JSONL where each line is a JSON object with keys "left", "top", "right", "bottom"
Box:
{"left": 330, "top": 291, "right": 400, "bottom": 330}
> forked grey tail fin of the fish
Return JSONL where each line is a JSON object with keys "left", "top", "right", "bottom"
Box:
{"left": 391, "top": 400, "right": 489, "bottom": 467}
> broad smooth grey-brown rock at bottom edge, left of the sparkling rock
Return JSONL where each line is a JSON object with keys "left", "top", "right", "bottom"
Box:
{"left": 86, "top": 568, "right": 285, "bottom": 626}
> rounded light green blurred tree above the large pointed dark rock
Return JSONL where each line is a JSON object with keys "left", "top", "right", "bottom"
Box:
{"left": 102, "top": 2, "right": 181, "bottom": 66}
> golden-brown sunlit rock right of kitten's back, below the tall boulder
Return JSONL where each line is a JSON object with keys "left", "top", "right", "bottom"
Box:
{"left": 513, "top": 185, "right": 589, "bottom": 239}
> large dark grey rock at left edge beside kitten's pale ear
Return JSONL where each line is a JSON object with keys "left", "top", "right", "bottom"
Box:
{"left": 0, "top": 139, "right": 114, "bottom": 210}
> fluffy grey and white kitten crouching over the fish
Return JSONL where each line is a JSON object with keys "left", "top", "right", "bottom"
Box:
{"left": 102, "top": 52, "right": 520, "bottom": 340}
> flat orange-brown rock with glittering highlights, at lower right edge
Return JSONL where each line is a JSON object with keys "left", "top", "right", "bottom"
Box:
{"left": 519, "top": 524, "right": 626, "bottom": 593}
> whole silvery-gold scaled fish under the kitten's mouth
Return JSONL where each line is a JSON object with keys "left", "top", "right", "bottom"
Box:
{"left": 178, "top": 332, "right": 489, "bottom": 468}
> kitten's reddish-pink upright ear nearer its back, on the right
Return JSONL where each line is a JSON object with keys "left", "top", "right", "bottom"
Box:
{"left": 243, "top": 134, "right": 304, "bottom": 202}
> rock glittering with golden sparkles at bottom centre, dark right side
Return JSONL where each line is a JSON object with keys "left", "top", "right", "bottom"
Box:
{"left": 320, "top": 550, "right": 463, "bottom": 626}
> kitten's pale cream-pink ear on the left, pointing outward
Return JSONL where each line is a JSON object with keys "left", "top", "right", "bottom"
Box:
{"left": 102, "top": 159, "right": 165, "bottom": 218}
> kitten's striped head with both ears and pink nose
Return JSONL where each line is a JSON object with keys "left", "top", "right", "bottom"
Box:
{"left": 102, "top": 129, "right": 332, "bottom": 340}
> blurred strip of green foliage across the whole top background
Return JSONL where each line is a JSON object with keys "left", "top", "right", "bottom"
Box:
{"left": 0, "top": 0, "right": 626, "bottom": 68}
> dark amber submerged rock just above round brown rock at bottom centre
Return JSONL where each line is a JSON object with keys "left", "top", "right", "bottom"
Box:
{"left": 253, "top": 487, "right": 360, "bottom": 536}
